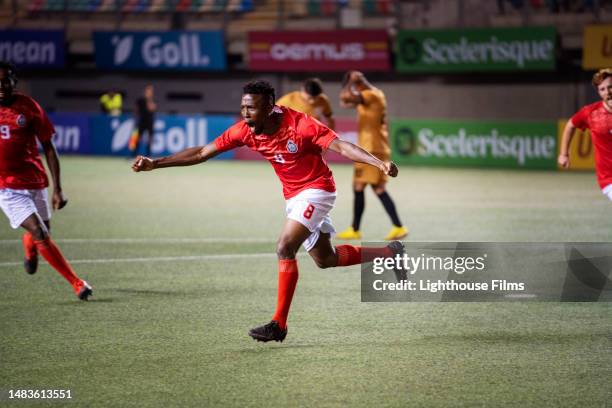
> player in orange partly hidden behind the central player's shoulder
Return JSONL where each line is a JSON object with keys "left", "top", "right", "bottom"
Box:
{"left": 276, "top": 78, "right": 336, "bottom": 130}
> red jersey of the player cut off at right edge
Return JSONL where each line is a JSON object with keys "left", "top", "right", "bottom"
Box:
{"left": 571, "top": 101, "right": 612, "bottom": 189}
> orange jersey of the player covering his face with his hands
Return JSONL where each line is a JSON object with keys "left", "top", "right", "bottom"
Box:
{"left": 357, "top": 88, "right": 391, "bottom": 155}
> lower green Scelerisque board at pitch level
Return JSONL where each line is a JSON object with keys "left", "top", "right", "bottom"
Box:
{"left": 390, "top": 119, "right": 557, "bottom": 169}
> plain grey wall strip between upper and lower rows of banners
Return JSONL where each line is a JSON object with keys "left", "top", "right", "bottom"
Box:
{"left": 20, "top": 74, "right": 592, "bottom": 120}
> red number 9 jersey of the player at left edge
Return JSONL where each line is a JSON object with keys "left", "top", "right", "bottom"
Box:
{"left": 0, "top": 93, "right": 55, "bottom": 190}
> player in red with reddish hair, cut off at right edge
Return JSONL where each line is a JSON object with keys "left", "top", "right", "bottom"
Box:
{"left": 557, "top": 68, "right": 612, "bottom": 200}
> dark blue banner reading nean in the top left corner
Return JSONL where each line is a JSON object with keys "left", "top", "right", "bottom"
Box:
{"left": 0, "top": 30, "right": 66, "bottom": 68}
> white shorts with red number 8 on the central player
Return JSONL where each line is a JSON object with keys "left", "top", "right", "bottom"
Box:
{"left": 285, "top": 188, "right": 336, "bottom": 251}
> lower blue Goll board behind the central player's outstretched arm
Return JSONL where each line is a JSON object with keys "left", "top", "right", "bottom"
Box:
{"left": 90, "top": 115, "right": 236, "bottom": 159}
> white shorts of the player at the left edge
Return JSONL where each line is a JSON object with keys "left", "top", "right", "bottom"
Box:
{"left": 0, "top": 188, "right": 51, "bottom": 229}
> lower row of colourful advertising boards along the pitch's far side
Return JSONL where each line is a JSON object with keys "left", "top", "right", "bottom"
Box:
{"left": 49, "top": 113, "right": 594, "bottom": 170}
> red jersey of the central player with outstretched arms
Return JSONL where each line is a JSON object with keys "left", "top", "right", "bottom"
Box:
{"left": 215, "top": 107, "right": 338, "bottom": 199}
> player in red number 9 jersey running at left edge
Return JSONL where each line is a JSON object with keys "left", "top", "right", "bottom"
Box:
{"left": 0, "top": 62, "right": 92, "bottom": 300}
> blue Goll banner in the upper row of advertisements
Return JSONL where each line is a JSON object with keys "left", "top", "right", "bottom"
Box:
{"left": 93, "top": 31, "right": 226, "bottom": 71}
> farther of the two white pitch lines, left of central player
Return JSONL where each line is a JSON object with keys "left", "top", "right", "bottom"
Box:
{"left": 0, "top": 238, "right": 276, "bottom": 245}
